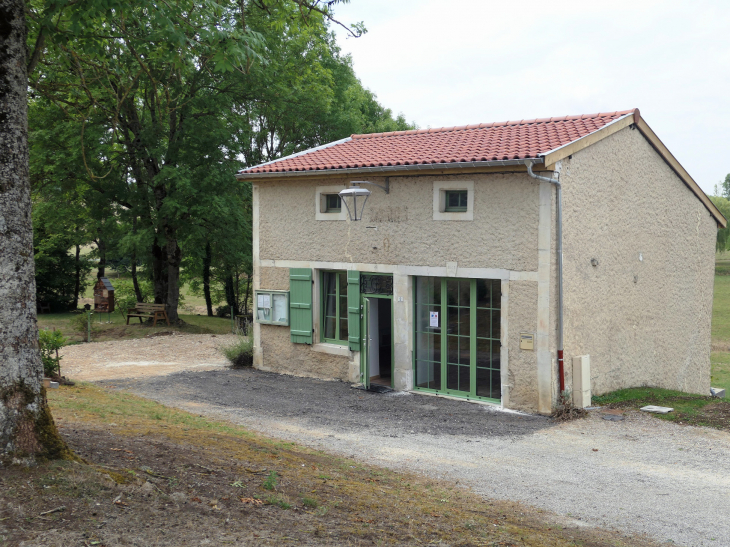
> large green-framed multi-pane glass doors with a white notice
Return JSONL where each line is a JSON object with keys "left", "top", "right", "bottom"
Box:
{"left": 415, "top": 277, "right": 501, "bottom": 400}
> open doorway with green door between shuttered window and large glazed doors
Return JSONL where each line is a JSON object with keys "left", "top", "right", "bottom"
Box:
{"left": 364, "top": 297, "right": 393, "bottom": 387}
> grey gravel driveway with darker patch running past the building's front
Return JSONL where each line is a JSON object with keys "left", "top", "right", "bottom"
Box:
{"left": 94, "top": 369, "right": 730, "bottom": 546}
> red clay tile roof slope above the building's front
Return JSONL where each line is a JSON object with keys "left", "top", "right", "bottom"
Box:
{"left": 241, "top": 110, "right": 635, "bottom": 174}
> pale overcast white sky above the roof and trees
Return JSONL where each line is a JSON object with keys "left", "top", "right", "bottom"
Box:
{"left": 336, "top": 0, "right": 730, "bottom": 194}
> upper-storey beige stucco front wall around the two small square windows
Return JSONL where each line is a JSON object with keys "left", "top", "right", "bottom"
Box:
{"left": 258, "top": 174, "right": 538, "bottom": 272}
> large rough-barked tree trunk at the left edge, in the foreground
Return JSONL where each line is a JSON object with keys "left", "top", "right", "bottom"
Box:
{"left": 0, "top": 0, "right": 71, "bottom": 465}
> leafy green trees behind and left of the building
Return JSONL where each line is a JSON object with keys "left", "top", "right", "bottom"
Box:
{"left": 26, "top": 0, "right": 413, "bottom": 321}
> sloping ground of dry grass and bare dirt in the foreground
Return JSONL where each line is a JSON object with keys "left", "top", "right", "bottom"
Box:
{"left": 0, "top": 385, "right": 658, "bottom": 547}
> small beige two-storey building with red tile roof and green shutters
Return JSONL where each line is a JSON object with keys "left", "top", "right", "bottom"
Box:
{"left": 237, "top": 110, "right": 726, "bottom": 413}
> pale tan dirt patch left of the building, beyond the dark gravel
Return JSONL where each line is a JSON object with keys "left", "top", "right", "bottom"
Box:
{"left": 60, "top": 331, "right": 236, "bottom": 382}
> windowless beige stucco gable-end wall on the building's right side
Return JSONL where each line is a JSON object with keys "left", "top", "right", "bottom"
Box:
{"left": 561, "top": 128, "right": 717, "bottom": 394}
